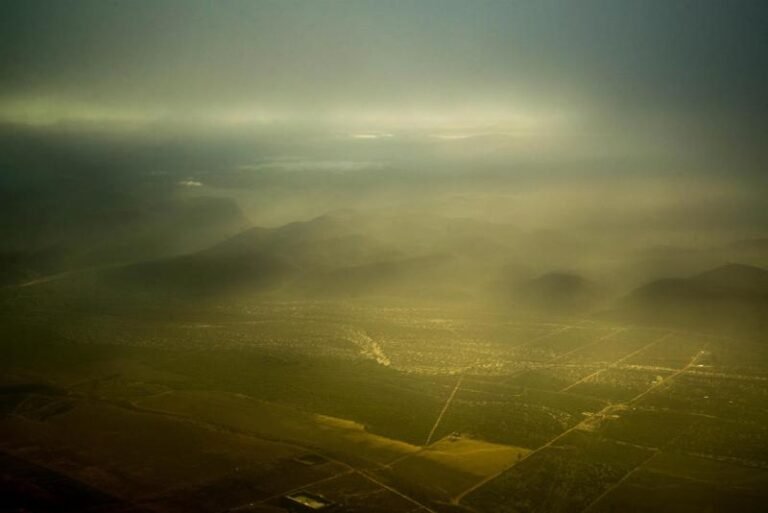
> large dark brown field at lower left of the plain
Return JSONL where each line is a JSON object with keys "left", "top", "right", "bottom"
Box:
{"left": 0, "top": 401, "right": 332, "bottom": 502}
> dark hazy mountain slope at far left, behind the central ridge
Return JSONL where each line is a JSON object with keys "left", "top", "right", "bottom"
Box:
{"left": 0, "top": 197, "right": 248, "bottom": 285}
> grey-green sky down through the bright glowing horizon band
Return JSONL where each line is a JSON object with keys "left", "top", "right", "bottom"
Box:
{"left": 0, "top": 0, "right": 768, "bottom": 156}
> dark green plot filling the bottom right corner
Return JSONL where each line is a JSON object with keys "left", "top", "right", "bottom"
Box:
{"left": 588, "top": 453, "right": 768, "bottom": 513}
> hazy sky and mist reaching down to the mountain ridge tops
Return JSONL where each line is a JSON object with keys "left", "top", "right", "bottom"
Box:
{"left": 0, "top": 0, "right": 768, "bottom": 264}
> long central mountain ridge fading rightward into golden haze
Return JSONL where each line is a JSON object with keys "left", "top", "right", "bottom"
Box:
{"left": 99, "top": 211, "right": 520, "bottom": 298}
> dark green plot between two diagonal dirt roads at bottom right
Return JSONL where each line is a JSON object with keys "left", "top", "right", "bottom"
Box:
{"left": 464, "top": 431, "right": 654, "bottom": 513}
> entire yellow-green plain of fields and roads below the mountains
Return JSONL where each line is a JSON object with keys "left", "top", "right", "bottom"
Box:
{"left": 0, "top": 303, "right": 768, "bottom": 513}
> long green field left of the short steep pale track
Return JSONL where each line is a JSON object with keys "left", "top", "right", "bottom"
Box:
{"left": 142, "top": 351, "right": 455, "bottom": 443}
